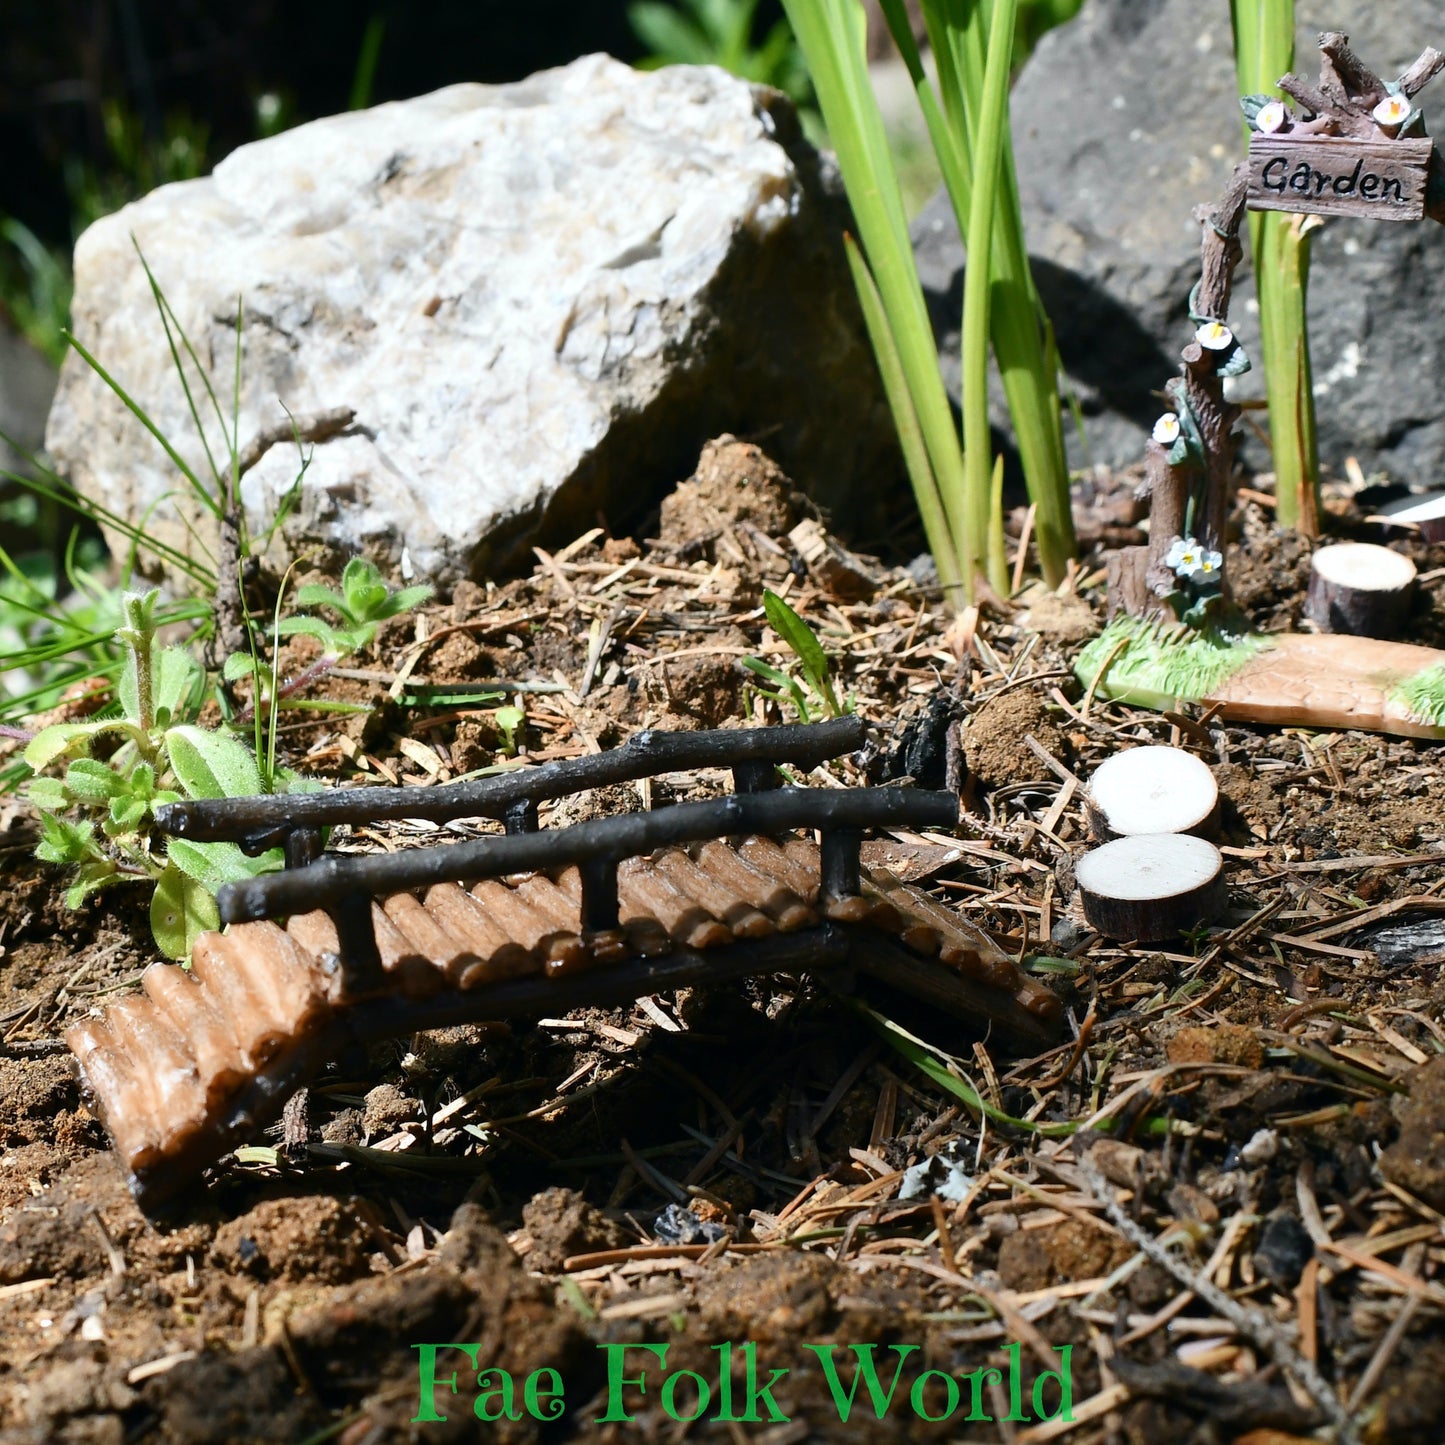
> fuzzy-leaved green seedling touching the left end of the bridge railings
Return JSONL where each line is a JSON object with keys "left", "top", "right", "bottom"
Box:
{"left": 23, "top": 590, "right": 303, "bottom": 958}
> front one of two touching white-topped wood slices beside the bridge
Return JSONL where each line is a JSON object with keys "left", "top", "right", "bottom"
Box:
{"left": 1074, "top": 832, "right": 1224, "bottom": 944}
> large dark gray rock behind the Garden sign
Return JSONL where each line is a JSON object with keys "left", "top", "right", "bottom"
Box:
{"left": 913, "top": 0, "right": 1445, "bottom": 483}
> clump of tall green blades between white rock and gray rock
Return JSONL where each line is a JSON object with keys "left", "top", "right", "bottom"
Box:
{"left": 783, "top": 0, "right": 1074, "bottom": 605}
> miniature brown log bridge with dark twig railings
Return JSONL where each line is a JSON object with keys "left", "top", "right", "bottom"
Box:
{"left": 66, "top": 718, "right": 1061, "bottom": 1205}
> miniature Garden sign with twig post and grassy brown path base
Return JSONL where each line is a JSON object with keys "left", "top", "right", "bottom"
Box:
{"left": 1077, "top": 32, "right": 1445, "bottom": 738}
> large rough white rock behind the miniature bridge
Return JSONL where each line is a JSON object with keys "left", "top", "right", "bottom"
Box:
{"left": 46, "top": 56, "right": 890, "bottom": 585}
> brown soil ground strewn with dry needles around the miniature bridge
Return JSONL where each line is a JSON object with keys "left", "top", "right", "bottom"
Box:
{"left": 0, "top": 445, "right": 1445, "bottom": 1445}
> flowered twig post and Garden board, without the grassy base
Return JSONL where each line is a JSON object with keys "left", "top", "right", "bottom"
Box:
{"left": 1108, "top": 30, "right": 1445, "bottom": 626}
